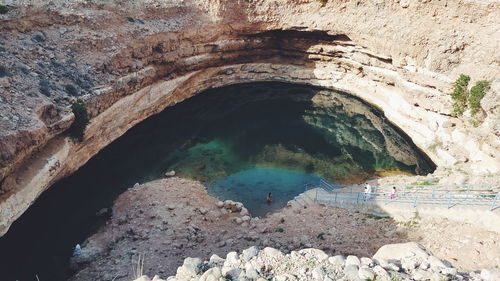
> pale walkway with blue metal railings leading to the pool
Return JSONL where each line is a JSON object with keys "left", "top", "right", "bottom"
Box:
{"left": 307, "top": 180, "right": 500, "bottom": 211}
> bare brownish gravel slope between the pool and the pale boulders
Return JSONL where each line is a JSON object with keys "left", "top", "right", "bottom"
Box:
{"left": 70, "top": 178, "right": 500, "bottom": 281}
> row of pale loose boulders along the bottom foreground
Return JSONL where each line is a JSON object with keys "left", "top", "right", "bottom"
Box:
{"left": 135, "top": 242, "right": 500, "bottom": 281}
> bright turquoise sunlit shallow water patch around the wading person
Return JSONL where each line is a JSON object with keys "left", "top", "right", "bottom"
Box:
{"left": 207, "top": 168, "right": 321, "bottom": 216}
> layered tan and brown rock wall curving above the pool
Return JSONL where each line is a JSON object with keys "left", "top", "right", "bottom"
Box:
{"left": 0, "top": 0, "right": 500, "bottom": 233}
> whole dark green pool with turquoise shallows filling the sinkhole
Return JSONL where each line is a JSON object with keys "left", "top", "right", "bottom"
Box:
{"left": 0, "top": 83, "right": 434, "bottom": 281}
